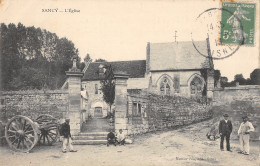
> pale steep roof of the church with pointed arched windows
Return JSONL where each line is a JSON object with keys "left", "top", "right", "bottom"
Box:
{"left": 147, "top": 40, "right": 209, "bottom": 71}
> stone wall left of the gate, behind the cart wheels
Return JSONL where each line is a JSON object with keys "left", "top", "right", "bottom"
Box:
{"left": 0, "top": 90, "right": 69, "bottom": 123}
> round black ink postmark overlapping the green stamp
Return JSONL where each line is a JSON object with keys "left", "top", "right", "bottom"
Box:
{"left": 191, "top": 8, "right": 245, "bottom": 60}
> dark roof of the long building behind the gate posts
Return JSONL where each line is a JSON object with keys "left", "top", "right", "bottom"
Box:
{"left": 82, "top": 60, "right": 146, "bottom": 81}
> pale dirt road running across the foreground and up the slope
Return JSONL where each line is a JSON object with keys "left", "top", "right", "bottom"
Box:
{"left": 0, "top": 121, "right": 259, "bottom": 166}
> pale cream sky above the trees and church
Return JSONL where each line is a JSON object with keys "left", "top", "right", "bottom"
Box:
{"left": 0, "top": 0, "right": 259, "bottom": 81}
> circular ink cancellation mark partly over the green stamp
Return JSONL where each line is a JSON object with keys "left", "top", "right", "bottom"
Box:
{"left": 191, "top": 8, "right": 244, "bottom": 60}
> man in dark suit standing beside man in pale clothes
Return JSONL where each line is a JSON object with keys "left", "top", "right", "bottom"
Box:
{"left": 219, "top": 114, "right": 232, "bottom": 152}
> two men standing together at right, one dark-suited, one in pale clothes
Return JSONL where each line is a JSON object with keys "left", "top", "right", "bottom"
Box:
{"left": 219, "top": 114, "right": 255, "bottom": 155}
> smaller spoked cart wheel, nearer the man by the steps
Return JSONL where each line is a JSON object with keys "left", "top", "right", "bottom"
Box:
{"left": 36, "top": 115, "right": 58, "bottom": 145}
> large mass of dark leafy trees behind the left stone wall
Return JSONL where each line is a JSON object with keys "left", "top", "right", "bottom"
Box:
{"left": 0, "top": 23, "right": 80, "bottom": 90}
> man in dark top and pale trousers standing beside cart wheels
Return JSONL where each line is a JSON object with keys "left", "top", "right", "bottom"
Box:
{"left": 60, "top": 118, "right": 77, "bottom": 153}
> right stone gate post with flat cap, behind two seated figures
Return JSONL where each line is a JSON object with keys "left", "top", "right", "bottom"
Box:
{"left": 114, "top": 73, "right": 129, "bottom": 134}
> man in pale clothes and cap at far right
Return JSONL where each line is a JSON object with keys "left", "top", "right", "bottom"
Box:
{"left": 238, "top": 116, "right": 255, "bottom": 155}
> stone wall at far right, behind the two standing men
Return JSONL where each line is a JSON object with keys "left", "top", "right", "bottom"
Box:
{"left": 212, "top": 85, "right": 260, "bottom": 140}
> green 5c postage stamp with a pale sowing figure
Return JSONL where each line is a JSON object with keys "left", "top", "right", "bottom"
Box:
{"left": 220, "top": 2, "right": 256, "bottom": 46}
